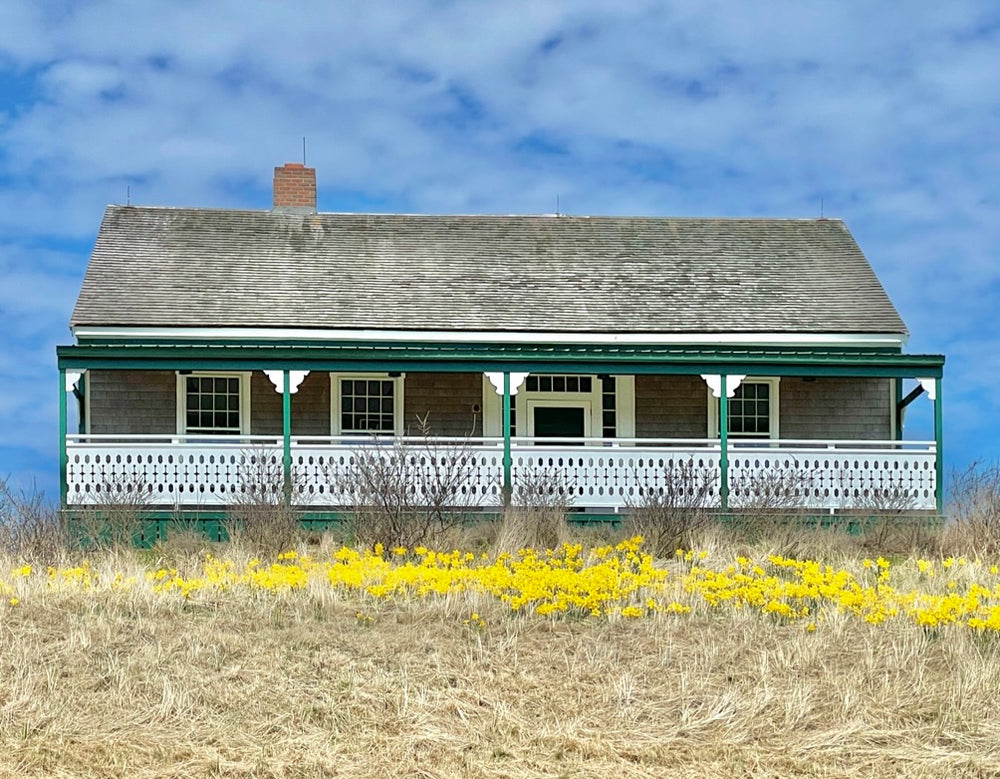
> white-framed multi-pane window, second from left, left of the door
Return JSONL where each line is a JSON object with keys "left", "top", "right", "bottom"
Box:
{"left": 332, "top": 374, "right": 403, "bottom": 435}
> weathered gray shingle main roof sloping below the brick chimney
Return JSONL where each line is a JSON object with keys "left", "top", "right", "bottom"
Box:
{"left": 71, "top": 206, "right": 906, "bottom": 333}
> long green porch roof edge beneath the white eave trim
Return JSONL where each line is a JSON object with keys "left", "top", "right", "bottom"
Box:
{"left": 57, "top": 342, "right": 944, "bottom": 378}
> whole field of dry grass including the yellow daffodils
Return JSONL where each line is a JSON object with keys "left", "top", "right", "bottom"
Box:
{"left": 0, "top": 539, "right": 1000, "bottom": 777}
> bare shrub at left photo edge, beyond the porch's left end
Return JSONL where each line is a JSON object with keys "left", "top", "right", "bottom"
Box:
{"left": 0, "top": 479, "right": 68, "bottom": 562}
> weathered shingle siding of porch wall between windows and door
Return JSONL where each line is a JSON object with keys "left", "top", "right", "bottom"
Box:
{"left": 87, "top": 370, "right": 892, "bottom": 440}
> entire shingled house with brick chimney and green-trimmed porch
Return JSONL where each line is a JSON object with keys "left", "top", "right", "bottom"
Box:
{"left": 57, "top": 164, "right": 944, "bottom": 513}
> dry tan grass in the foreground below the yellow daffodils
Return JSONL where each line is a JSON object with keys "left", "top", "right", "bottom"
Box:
{"left": 0, "top": 552, "right": 1000, "bottom": 777}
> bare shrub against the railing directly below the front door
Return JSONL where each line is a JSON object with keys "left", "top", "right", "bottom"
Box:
{"left": 493, "top": 468, "right": 575, "bottom": 554}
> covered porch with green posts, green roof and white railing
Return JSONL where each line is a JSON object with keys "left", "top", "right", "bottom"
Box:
{"left": 59, "top": 343, "right": 943, "bottom": 513}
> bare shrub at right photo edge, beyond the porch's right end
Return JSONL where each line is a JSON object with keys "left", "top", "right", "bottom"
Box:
{"left": 948, "top": 463, "right": 1000, "bottom": 559}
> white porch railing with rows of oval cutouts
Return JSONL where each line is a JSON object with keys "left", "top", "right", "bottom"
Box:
{"left": 66, "top": 434, "right": 936, "bottom": 510}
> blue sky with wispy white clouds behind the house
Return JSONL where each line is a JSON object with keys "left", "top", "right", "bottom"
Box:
{"left": 0, "top": 0, "right": 1000, "bottom": 502}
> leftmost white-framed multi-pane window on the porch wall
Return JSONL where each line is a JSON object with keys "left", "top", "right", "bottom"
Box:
{"left": 177, "top": 373, "right": 249, "bottom": 435}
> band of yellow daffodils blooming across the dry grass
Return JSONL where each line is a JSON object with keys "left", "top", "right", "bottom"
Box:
{"left": 0, "top": 537, "right": 1000, "bottom": 632}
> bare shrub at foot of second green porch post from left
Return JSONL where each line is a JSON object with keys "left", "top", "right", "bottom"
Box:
{"left": 225, "top": 446, "right": 302, "bottom": 554}
